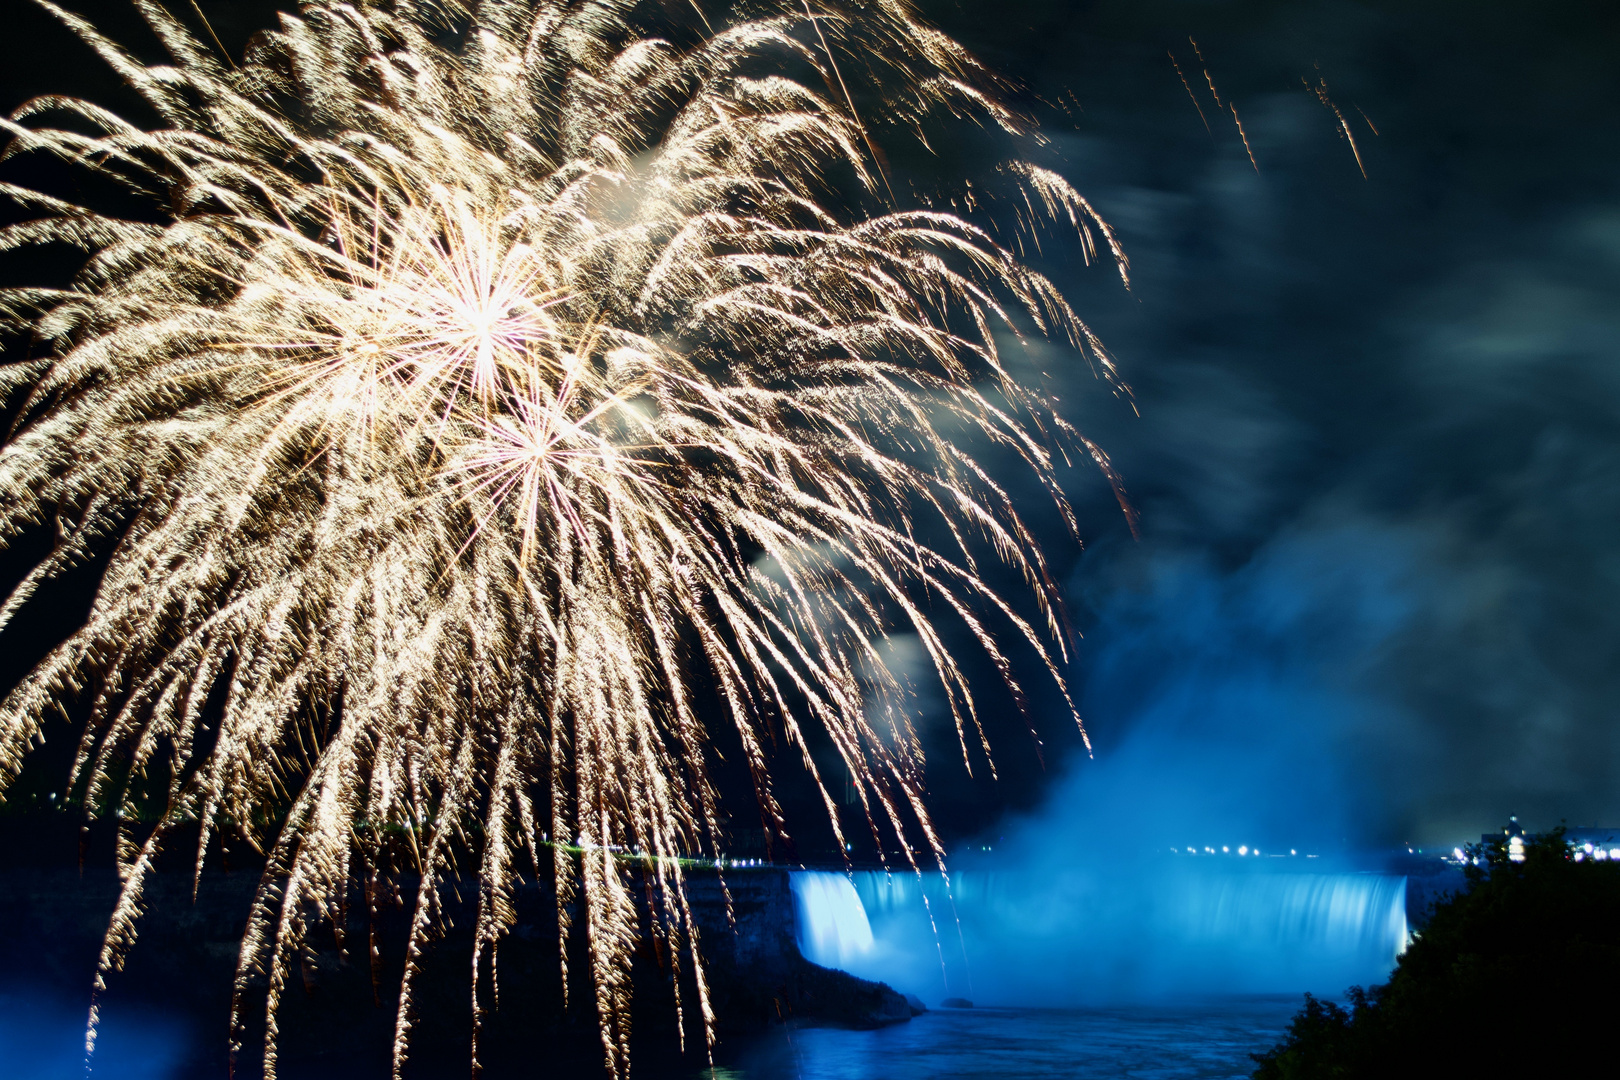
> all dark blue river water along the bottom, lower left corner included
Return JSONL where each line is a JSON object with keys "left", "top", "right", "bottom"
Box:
{"left": 0, "top": 988, "right": 1301, "bottom": 1080}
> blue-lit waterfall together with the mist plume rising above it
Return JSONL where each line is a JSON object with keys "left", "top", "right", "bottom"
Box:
{"left": 795, "top": 528, "right": 1427, "bottom": 1006}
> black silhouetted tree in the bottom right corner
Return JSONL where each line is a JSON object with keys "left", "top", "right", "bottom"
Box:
{"left": 1254, "top": 827, "right": 1620, "bottom": 1080}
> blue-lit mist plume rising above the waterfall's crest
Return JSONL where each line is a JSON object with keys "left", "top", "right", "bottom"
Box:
{"left": 1062, "top": 528, "right": 1427, "bottom": 857}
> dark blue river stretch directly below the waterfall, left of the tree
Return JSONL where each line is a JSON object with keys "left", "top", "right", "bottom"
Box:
{"left": 671, "top": 994, "right": 1301, "bottom": 1080}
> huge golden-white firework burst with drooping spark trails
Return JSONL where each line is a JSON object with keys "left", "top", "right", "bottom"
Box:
{"left": 0, "top": 0, "right": 1127, "bottom": 1077}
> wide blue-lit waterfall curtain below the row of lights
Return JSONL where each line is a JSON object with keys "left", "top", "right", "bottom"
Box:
{"left": 792, "top": 860, "right": 1406, "bottom": 1006}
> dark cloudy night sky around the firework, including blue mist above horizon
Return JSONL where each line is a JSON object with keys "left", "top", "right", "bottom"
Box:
{"left": 0, "top": 0, "right": 1620, "bottom": 847}
